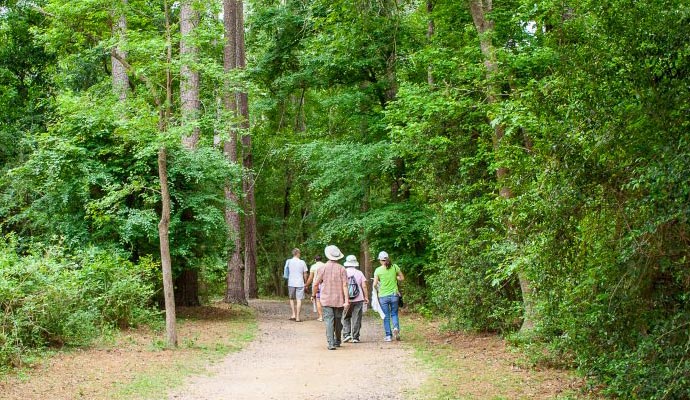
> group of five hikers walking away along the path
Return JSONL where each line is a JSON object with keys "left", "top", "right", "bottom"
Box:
{"left": 284, "top": 245, "right": 405, "bottom": 350}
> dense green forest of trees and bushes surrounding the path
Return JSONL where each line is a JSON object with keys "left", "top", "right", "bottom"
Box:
{"left": 0, "top": 0, "right": 690, "bottom": 399}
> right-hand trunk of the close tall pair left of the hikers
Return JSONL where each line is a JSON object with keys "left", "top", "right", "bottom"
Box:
{"left": 235, "top": 0, "right": 259, "bottom": 299}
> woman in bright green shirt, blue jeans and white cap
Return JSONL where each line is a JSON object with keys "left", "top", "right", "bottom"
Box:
{"left": 374, "top": 251, "right": 405, "bottom": 342}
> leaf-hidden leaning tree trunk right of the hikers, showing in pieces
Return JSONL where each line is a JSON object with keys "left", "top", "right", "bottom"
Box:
{"left": 470, "top": 0, "right": 535, "bottom": 333}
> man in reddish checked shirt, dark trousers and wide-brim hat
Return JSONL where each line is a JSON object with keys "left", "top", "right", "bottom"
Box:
{"left": 314, "top": 245, "right": 350, "bottom": 350}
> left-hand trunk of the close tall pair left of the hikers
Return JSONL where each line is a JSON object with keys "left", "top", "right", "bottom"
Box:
{"left": 223, "top": 0, "right": 247, "bottom": 304}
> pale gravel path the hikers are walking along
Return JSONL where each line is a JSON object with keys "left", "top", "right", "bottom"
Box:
{"left": 169, "top": 300, "right": 427, "bottom": 400}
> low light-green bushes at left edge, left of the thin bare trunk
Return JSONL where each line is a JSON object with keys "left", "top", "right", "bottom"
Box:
{"left": 0, "top": 237, "right": 158, "bottom": 366}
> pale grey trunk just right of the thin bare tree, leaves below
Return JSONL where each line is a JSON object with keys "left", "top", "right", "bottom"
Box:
{"left": 180, "top": 0, "right": 200, "bottom": 149}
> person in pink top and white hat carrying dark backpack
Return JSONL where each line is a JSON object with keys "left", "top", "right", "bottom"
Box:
{"left": 343, "top": 255, "right": 369, "bottom": 343}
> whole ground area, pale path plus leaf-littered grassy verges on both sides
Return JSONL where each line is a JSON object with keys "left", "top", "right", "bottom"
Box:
{"left": 0, "top": 300, "right": 583, "bottom": 400}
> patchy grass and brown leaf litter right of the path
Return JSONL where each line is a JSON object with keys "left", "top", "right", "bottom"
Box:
{"left": 401, "top": 314, "right": 590, "bottom": 400}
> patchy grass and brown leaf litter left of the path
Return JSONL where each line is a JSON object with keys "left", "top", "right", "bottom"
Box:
{"left": 0, "top": 303, "right": 258, "bottom": 400}
